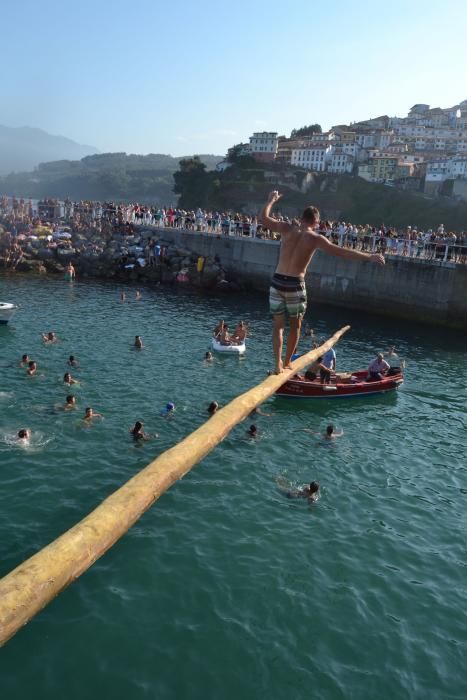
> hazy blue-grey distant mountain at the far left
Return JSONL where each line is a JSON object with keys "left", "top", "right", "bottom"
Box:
{"left": 0, "top": 125, "right": 99, "bottom": 175}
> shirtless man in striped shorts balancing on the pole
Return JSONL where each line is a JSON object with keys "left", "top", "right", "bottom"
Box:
{"left": 259, "top": 191, "right": 384, "bottom": 374}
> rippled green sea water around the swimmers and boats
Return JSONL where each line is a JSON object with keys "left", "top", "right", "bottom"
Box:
{"left": 0, "top": 276, "right": 467, "bottom": 700}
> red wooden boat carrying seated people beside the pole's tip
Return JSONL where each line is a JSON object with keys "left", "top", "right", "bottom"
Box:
{"left": 276, "top": 369, "right": 404, "bottom": 399}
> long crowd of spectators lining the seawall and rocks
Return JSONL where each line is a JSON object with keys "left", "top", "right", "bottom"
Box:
{"left": 0, "top": 197, "right": 467, "bottom": 265}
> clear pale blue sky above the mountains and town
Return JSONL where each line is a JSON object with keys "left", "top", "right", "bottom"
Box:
{"left": 0, "top": 0, "right": 467, "bottom": 155}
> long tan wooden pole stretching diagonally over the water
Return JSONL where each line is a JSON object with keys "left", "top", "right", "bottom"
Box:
{"left": 0, "top": 326, "right": 350, "bottom": 646}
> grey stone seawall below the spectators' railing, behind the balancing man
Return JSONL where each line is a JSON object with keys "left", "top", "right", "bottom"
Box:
{"left": 149, "top": 229, "right": 467, "bottom": 330}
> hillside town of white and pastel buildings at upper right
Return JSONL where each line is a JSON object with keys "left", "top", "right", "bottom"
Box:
{"left": 217, "top": 100, "right": 467, "bottom": 199}
